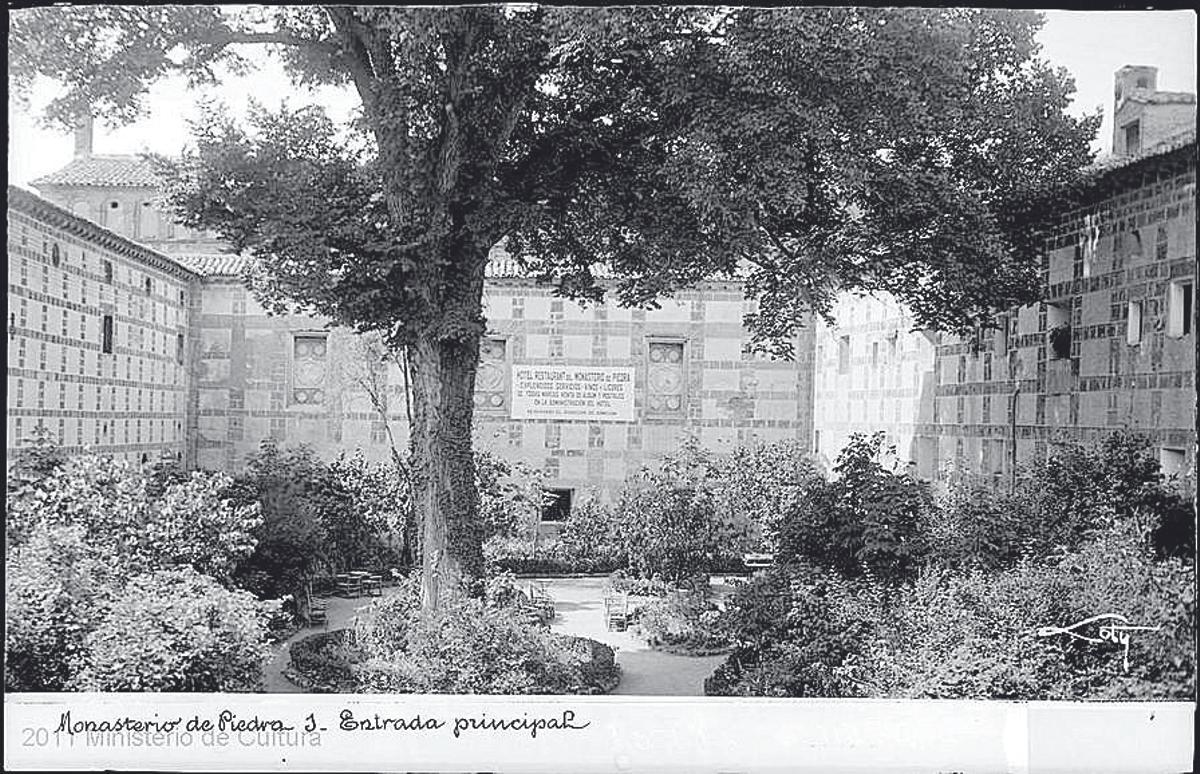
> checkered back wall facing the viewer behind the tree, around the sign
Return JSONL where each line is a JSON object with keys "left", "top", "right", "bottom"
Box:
{"left": 190, "top": 278, "right": 811, "bottom": 494}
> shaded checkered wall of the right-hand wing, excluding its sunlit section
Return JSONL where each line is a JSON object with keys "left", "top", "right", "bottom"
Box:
{"left": 918, "top": 143, "right": 1196, "bottom": 478}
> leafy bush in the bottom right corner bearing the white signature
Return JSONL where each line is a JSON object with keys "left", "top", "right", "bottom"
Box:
{"left": 871, "top": 527, "right": 1195, "bottom": 700}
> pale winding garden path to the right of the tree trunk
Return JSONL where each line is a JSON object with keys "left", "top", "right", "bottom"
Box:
{"left": 542, "top": 577, "right": 725, "bottom": 696}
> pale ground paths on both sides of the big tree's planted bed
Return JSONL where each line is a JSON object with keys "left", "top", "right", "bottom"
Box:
{"left": 263, "top": 577, "right": 725, "bottom": 696}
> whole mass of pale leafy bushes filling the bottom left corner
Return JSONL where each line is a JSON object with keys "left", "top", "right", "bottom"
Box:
{"left": 5, "top": 444, "right": 277, "bottom": 691}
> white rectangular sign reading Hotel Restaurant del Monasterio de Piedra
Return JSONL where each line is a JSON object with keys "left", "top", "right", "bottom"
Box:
{"left": 512, "top": 365, "right": 634, "bottom": 422}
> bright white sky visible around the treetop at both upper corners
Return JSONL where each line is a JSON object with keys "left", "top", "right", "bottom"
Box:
{"left": 8, "top": 11, "right": 1196, "bottom": 186}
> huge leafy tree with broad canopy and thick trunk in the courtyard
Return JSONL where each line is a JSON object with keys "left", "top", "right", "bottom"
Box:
{"left": 10, "top": 5, "right": 1098, "bottom": 605}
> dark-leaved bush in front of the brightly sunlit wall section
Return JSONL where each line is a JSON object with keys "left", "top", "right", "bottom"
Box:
{"left": 778, "top": 433, "right": 932, "bottom": 581}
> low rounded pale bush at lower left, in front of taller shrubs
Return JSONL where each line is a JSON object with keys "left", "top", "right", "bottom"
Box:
{"left": 71, "top": 568, "right": 270, "bottom": 692}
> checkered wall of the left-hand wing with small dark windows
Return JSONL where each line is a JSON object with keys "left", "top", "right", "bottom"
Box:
{"left": 7, "top": 187, "right": 197, "bottom": 461}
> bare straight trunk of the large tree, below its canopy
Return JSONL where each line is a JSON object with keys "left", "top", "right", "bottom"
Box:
{"left": 408, "top": 307, "right": 484, "bottom": 610}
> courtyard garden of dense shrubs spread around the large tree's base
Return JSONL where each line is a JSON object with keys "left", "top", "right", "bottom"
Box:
{"left": 5, "top": 433, "right": 1195, "bottom": 700}
